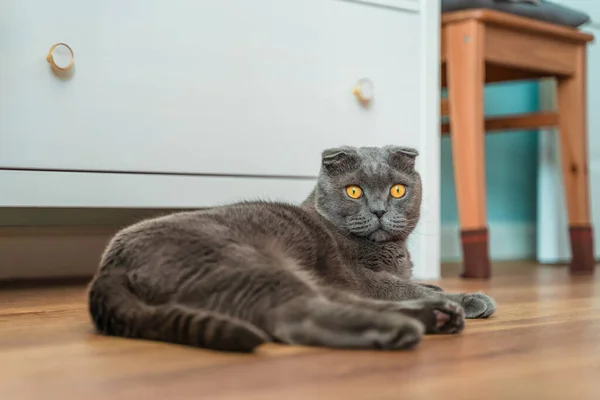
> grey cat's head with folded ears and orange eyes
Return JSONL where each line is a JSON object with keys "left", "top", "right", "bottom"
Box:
{"left": 314, "top": 146, "right": 421, "bottom": 242}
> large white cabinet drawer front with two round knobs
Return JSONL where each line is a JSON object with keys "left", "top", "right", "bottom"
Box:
{"left": 0, "top": 0, "right": 422, "bottom": 176}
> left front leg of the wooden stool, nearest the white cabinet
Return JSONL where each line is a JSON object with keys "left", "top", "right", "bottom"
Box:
{"left": 446, "top": 20, "right": 491, "bottom": 278}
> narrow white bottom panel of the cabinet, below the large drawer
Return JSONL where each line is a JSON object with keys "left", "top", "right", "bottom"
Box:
{"left": 0, "top": 170, "right": 316, "bottom": 209}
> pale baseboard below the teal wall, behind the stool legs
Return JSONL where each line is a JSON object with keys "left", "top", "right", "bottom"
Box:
{"left": 441, "top": 222, "right": 536, "bottom": 262}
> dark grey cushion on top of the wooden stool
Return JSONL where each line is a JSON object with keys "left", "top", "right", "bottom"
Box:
{"left": 442, "top": 0, "right": 598, "bottom": 27}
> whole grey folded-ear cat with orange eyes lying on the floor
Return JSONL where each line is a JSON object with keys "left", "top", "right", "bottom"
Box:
{"left": 89, "top": 146, "right": 496, "bottom": 351}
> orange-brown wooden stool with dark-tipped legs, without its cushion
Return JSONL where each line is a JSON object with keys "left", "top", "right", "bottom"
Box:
{"left": 441, "top": 9, "right": 594, "bottom": 278}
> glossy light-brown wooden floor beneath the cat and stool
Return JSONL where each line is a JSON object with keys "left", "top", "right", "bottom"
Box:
{"left": 0, "top": 264, "right": 600, "bottom": 400}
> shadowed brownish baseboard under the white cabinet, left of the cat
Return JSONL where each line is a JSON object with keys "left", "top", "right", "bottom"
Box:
{"left": 0, "top": 227, "right": 117, "bottom": 280}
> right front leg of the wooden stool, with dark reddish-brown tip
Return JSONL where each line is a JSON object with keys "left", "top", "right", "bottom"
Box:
{"left": 557, "top": 46, "right": 595, "bottom": 274}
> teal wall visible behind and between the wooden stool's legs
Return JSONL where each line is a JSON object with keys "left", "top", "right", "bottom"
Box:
{"left": 441, "top": 82, "right": 539, "bottom": 230}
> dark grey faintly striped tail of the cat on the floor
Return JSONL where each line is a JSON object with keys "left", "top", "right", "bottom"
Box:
{"left": 88, "top": 270, "right": 269, "bottom": 352}
